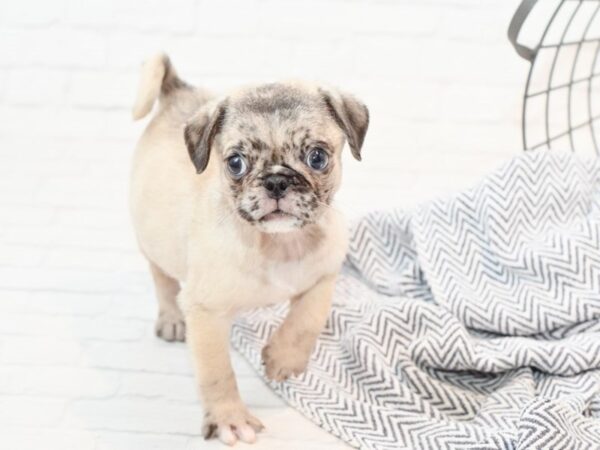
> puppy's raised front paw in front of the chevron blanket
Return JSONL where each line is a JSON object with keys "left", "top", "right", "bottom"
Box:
{"left": 262, "top": 335, "right": 311, "bottom": 381}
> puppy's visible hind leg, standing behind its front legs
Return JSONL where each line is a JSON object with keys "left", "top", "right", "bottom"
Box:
{"left": 150, "top": 262, "right": 185, "bottom": 342}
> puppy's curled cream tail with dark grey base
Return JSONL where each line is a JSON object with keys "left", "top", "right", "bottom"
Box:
{"left": 131, "top": 52, "right": 187, "bottom": 120}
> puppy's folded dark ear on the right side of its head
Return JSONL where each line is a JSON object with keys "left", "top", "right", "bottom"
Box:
{"left": 321, "top": 90, "right": 369, "bottom": 161}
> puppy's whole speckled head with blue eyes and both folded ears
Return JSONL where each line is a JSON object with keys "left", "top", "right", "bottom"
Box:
{"left": 186, "top": 84, "right": 368, "bottom": 233}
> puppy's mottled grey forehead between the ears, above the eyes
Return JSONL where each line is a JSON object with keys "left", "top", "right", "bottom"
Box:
{"left": 222, "top": 84, "right": 343, "bottom": 152}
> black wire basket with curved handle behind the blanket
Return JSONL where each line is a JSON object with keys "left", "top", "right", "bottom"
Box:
{"left": 508, "top": 0, "right": 600, "bottom": 155}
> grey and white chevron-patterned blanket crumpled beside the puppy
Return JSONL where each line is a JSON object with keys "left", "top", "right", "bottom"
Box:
{"left": 232, "top": 151, "right": 600, "bottom": 450}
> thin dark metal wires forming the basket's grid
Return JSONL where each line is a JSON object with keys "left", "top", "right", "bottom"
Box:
{"left": 508, "top": 0, "right": 600, "bottom": 155}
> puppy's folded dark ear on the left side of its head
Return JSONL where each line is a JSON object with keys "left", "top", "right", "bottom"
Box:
{"left": 183, "top": 102, "right": 227, "bottom": 173}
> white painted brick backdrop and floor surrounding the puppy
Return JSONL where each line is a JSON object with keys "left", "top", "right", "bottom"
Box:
{"left": 0, "top": 0, "right": 528, "bottom": 450}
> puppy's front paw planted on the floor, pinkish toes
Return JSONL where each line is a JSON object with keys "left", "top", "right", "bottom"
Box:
{"left": 202, "top": 405, "right": 265, "bottom": 445}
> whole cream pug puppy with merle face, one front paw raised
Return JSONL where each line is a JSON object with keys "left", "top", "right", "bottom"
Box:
{"left": 130, "top": 54, "right": 369, "bottom": 445}
